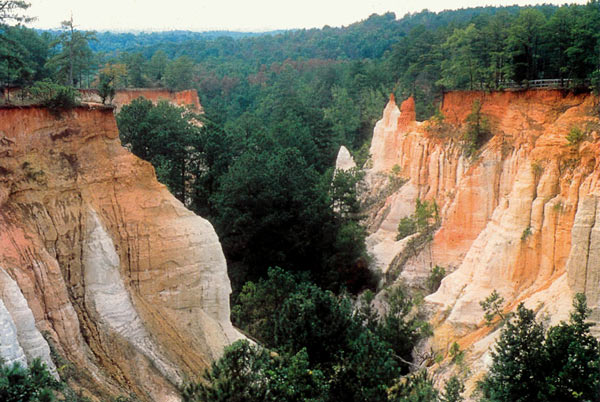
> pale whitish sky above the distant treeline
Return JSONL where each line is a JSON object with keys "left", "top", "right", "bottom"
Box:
{"left": 28, "top": 0, "right": 586, "bottom": 31}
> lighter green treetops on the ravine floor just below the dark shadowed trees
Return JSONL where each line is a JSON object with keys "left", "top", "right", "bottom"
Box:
{"left": 233, "top": 268, "right": 431, "bottom": 401}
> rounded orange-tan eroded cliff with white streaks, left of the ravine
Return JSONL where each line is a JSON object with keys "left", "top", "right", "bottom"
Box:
{"left": 0, "top": 106, "right": 240, "bottom": 401}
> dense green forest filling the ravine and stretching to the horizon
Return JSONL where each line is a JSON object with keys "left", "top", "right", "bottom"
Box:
{"left": 0, "top": 1, "right": 600, "bottom": 401}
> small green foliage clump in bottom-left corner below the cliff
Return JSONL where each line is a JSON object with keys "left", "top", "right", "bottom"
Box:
{"left": 0, "top": 359, "right": 61, "bottom": 402}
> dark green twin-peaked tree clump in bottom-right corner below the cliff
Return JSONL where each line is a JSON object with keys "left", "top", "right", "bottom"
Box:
{"left": 479, "top": 294, "right": 600, "bottom": 401}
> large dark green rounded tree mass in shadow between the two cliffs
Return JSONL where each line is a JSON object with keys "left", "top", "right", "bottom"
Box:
{"left": 211, "top": 137, "right": 368, "bottom": 291}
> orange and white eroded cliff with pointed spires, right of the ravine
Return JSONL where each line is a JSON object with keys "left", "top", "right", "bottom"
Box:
{"left": 338, "top": 90, "right": 600, "bottom": 394}
